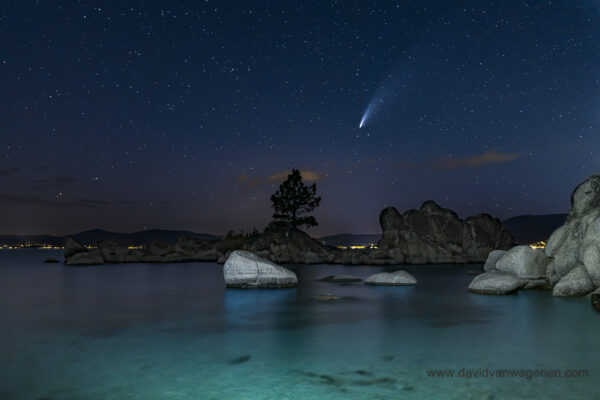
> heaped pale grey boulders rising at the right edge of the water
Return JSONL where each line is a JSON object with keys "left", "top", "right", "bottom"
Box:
{"left": 469, "top": 175, "right": 600, "bottom": 301}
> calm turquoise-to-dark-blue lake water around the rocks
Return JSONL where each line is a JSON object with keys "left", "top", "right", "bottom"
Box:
{"left": 0, "top": 250, "right": 600, "bottom": 400}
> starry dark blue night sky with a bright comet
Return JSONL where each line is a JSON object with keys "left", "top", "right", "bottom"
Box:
{"left": 0, "top": 0, "right": 600, "bottom": 236}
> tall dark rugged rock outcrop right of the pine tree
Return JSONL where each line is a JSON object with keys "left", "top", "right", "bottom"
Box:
{"left": 378, "top": 200, "right": 514, "bottom": 264}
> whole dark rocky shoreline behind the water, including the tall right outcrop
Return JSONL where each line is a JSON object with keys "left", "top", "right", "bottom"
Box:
{"left": 65, "top": 201, "right": 513, "bottom": 265}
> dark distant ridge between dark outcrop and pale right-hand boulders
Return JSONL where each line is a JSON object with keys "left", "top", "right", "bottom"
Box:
{"left": 502, "top": 214, "right": 567, "bottom": 244}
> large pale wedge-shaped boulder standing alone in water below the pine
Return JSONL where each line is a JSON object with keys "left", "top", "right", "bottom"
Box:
{"left": 223, "top": 250, "right": 298, "bottom": 288}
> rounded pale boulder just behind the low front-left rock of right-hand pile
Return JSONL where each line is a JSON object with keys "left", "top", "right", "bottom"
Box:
{"left": 496, "top": 245, "right": 550, "bottom": 279}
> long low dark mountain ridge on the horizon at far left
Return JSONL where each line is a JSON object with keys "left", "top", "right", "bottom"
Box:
{"left": 0, "top": 229, "right": 220, "bottom": 246}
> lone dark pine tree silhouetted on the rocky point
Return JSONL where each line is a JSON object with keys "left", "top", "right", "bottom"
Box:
{"left": 271, "top": 169, "right": 321, "bottom": 229}
